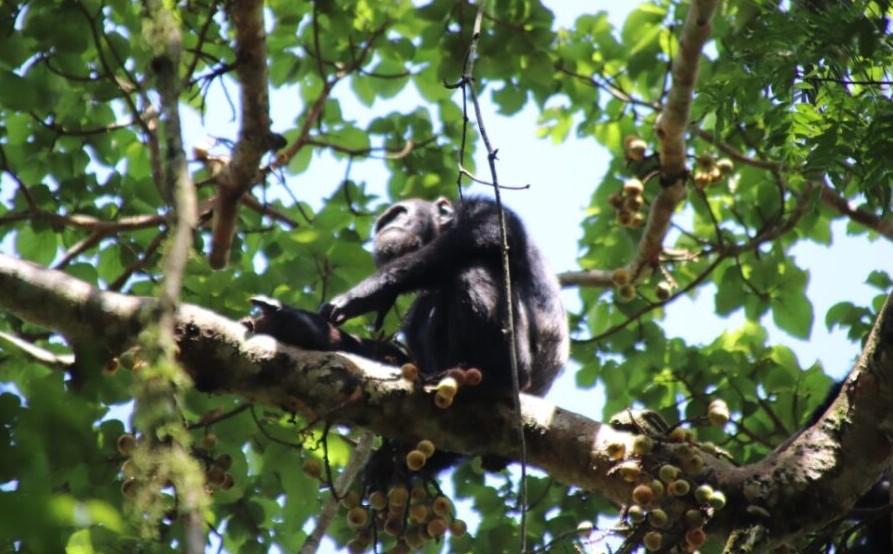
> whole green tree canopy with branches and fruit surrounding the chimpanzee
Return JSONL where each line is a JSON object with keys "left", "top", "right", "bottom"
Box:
{"left": 0, "top": 0, "right": 893, "bottom": 554}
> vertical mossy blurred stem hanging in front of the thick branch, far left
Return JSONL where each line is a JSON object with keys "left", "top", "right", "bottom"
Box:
{"left": 140, "top": 0, "right": 208, "bottom": 554}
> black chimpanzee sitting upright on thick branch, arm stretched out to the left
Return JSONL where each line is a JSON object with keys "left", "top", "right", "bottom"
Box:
{"left": 321, "top": 198, "right": 568, "bottom": 395}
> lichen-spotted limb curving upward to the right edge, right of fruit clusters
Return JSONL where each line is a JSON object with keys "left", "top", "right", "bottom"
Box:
{"left": 719, "top": 288, "right": 893, "bottom": 552}
